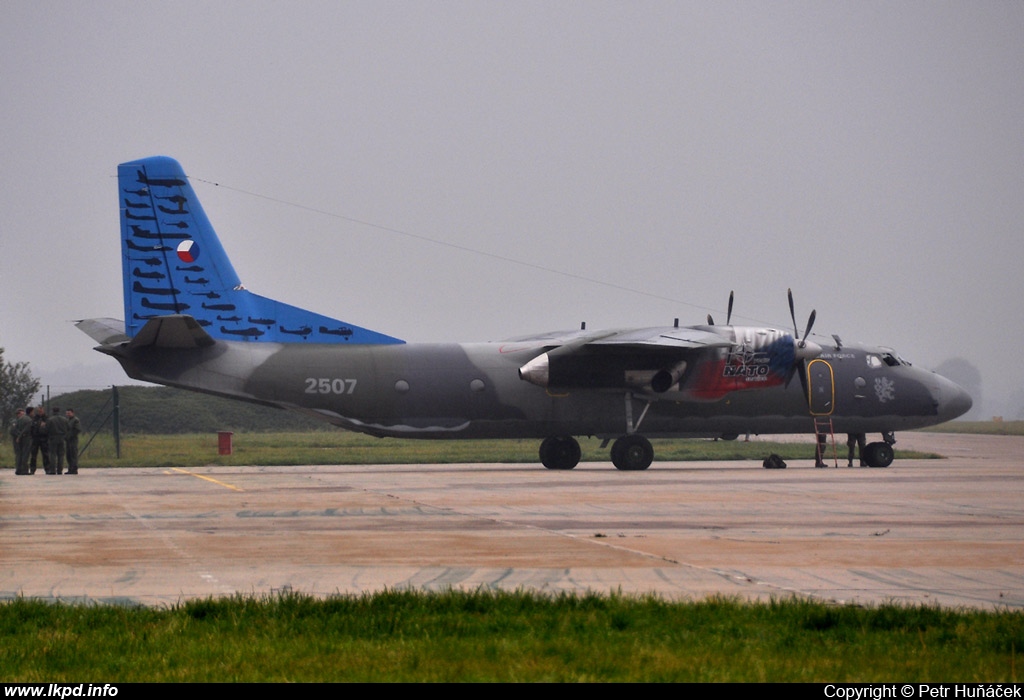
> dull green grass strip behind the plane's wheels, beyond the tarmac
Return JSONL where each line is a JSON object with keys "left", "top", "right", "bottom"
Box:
{"left": 44, "top": 430, "right": 936, "bottom": 469}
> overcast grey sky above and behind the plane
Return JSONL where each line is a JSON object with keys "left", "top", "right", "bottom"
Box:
{"left": 0, "top": 0, "right": 1024, "bottom": 411}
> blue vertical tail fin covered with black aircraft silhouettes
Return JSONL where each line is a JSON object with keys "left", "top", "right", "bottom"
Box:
{"left": 118, "top": 156, "right": 402, "bottom": 344}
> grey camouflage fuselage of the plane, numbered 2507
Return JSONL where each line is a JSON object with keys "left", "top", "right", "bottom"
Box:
{"left": 104, "top": 329, "right": 971, "bottom": 439}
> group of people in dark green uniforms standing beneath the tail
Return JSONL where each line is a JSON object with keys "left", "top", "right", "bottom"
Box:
{"left": 9, "top": 406, "right": 82, "bottom": 475}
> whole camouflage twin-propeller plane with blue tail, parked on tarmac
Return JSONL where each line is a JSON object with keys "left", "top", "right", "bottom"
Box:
{"left": 78, "top": 157, "right": 971, "bottom": 470}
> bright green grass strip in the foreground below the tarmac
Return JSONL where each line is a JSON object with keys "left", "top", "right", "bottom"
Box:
{"left": 0, "top": 590, "right": 1024, "bottom": 683}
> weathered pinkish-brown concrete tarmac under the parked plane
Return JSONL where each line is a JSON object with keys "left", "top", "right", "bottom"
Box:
{"left": 0, "top": 433, "right": 1024, "bottom": 609}
